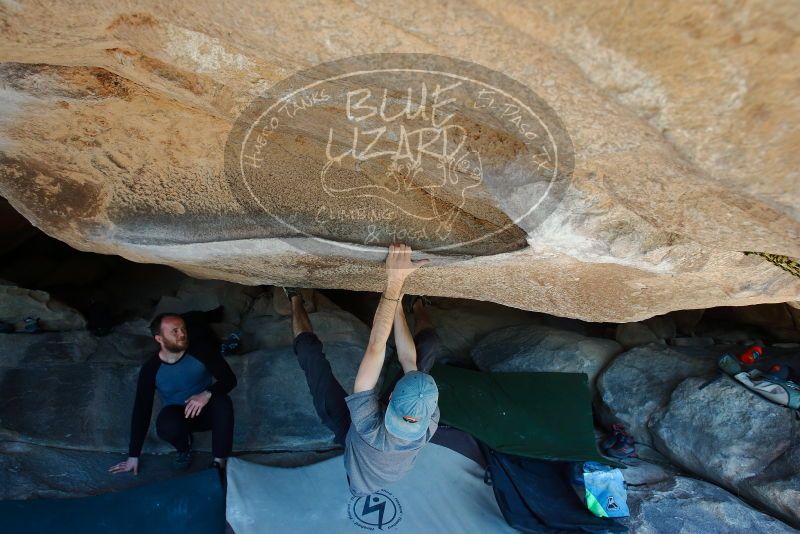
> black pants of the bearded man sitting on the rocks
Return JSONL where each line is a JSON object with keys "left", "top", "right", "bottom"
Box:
{"left": 156, "top": 394, "right": 233, "bottom": 458}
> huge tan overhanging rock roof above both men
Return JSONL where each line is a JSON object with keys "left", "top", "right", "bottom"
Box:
{"left": 0, "top": 0, "right": 800, "bottom": 322}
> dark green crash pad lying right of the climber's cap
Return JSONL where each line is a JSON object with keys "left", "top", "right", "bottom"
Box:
{"left": 384, "top": 365, "right": 622, "bottom": 467}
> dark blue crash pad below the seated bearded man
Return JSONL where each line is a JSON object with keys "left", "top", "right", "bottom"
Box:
{"left": 0, "top": 469, "right": 225, "bottom": 534}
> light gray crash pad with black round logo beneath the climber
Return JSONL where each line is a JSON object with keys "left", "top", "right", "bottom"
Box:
{"left": 227, "top": 444, "right": 516, "bottom": 534}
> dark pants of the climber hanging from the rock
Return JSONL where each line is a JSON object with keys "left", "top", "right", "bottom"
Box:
{"left": 294, "top": 328, "right": 442, "bottom": 445}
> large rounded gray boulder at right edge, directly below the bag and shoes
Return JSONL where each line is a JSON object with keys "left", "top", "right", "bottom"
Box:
{"left": 650, "top": 378, "right": 800, "bottom": 525}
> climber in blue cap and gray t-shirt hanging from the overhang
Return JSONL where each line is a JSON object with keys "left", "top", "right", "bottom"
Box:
{"left": 285, "top": 244, "right": 439, "bottom": 495}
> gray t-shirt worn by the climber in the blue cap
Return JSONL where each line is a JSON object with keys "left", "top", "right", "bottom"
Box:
{"left": 344, "top": 389, "right": 439, "bottom": 496}
